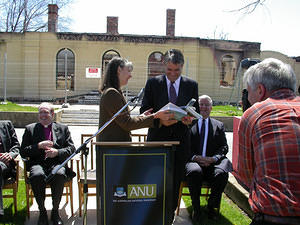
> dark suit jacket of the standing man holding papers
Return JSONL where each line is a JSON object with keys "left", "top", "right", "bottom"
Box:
{"left": 140, "top": 75, "right": 199, "bottom": 141}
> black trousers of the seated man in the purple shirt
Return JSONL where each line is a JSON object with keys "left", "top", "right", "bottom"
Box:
{"left": 29, "top": 165, "right": 67, "bottom": 211}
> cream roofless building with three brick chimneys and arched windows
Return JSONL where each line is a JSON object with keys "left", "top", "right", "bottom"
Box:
{"left": 0, "top": 5, "right": 300, "bottom": 102}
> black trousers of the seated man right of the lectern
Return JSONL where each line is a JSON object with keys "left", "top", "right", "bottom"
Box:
{"left": 186, "top": 162, "right": 228, "bottom": 212}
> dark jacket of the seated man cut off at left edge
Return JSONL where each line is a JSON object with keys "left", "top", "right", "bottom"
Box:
{"left": 0, "top": 120, "right": 20, "bottom": 177}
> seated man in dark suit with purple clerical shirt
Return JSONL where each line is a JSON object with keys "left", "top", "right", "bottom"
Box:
{"left": 20, "top": 103, "right": 75, "bottom": 225}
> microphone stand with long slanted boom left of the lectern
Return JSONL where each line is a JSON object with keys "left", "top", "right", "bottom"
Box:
{"left": 45, "top": 89, "right": 144, "bottom": 225}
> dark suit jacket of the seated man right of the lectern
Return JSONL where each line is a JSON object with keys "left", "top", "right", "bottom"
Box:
{"left": 189, "top": 118, "right": 232, "bottom": 172}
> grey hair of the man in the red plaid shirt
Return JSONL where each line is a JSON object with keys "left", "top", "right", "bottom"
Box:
{"left": 243, "top": 58, "right": 297, "bottom": 92}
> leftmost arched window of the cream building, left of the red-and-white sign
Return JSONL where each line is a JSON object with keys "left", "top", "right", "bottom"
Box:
{"left": 56, "top": 48, "right": 75, "bottom": 91}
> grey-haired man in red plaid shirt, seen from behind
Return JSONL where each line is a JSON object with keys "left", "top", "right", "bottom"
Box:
{"left": 237, "top": 58, "right": 300, "bottom": 225}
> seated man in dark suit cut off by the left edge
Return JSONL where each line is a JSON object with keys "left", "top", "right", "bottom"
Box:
{"left": 0, "top": 120, "right": 20, "bottom": 216}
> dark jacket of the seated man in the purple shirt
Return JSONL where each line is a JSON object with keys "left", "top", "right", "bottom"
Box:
{"left": 20, "top": 122, "right": 75, "bottom": 172}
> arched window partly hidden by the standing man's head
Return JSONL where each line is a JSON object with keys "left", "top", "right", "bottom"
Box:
{"left": 148, "top": 52, "right": 165, "bottom": 77}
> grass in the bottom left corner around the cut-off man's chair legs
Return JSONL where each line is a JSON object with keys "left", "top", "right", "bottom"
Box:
{"left": 0, "top": 180, "right": 27, "bottom": 225}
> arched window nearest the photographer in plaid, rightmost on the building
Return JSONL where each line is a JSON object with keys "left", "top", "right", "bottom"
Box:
{"left": 220, "top": 55, "right": 237, "bottom": 87}
